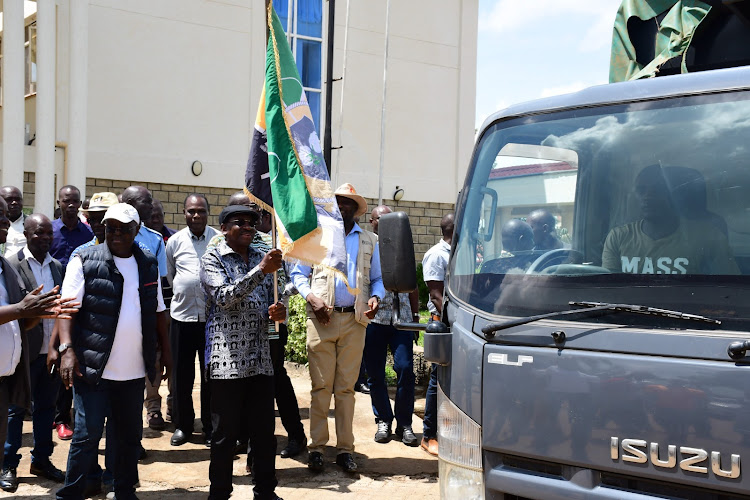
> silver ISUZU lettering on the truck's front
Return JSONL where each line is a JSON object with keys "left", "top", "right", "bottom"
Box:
{"left": 609, "top": 437, "right": 740, "bottom": 479}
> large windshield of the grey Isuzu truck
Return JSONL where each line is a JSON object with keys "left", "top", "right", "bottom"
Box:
{"left": 456, "top": 92, "right": 750, "bottom": 329}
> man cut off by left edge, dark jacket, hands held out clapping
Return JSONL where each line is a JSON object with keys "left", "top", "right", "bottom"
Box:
{"left": 0, "top": 196, "right": 75, "bottom": 492}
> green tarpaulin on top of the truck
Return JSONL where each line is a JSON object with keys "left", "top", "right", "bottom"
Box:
{"left": 609, "top": 0, "right": 711, "bottom": 83}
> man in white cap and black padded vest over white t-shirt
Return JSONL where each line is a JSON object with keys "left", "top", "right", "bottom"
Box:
{"left": 57, "top": 203, "right": 166, "bottom": 499}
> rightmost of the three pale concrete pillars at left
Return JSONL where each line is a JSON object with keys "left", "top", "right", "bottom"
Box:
{"left": 68, "top": 0, "right": 89, "bottom": 192}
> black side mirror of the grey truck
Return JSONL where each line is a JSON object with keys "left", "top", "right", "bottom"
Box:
{"left": 378, "top": 212, "right": 417, "bottom": 293}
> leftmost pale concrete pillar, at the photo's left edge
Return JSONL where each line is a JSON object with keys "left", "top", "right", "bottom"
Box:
{"left": 2, "top": 0, "right": 26, "bottom": 190}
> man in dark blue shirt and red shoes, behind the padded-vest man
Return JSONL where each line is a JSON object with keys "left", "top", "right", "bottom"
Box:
{"left": 49, "top": 186, "right": 94, "bottom": 440}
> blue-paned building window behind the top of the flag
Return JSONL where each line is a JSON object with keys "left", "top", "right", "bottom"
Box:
{"left": 273, "top": 0, "right": 323, "bottom": 135}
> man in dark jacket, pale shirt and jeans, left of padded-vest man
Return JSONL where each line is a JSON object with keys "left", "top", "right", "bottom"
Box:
{"left": 3, "top": 214, "right": 65, "bottom": 483}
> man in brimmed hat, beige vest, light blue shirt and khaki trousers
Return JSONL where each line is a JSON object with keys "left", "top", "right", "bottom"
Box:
{"left": 291, "top": 183, "right": 385, "bottom": 472}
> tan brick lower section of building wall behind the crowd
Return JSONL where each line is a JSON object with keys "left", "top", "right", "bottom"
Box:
{"left": 23, "top": 172, "right": 453, "bottom": 263}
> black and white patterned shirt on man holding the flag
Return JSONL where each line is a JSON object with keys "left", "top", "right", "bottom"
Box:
{"left": 200, "top": 241, "right": 273, "bottom": 379}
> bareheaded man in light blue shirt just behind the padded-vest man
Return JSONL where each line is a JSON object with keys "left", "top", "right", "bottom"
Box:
{"left": 122, "top": 186, "right": 172, "bottom": 431}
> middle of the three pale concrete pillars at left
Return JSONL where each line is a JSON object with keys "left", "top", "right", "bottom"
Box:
{"left": 34, "top": 0, "right": 57, "bottom": 214}
